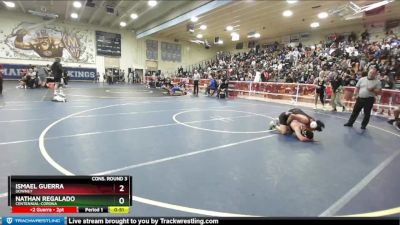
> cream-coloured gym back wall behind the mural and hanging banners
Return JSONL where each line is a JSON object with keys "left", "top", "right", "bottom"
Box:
{"left": 0, "top": 10, "right": 217, "bottom": 79}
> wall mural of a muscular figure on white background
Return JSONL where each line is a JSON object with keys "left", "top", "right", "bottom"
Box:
{"left": 0, "top": 22, "right": 95, "bottom": 63}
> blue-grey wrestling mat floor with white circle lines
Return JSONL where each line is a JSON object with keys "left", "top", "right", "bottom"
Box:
{"left": 0, "top": 81, "right": 400, "bottom": 216}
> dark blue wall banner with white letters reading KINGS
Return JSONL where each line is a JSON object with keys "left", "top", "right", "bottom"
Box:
{"left": 2, "top": 64, "right": 97, "bottom": 81}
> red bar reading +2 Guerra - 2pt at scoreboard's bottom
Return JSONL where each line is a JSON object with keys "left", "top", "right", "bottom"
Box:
{"left": 11, "top": 206, "right": 78, "bottom": 214}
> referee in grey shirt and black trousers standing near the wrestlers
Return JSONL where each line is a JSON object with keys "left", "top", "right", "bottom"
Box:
{"left": 344, "top": 65, "right": 382, "bottom": 130}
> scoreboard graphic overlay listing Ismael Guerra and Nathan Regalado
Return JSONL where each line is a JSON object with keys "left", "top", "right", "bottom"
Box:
{"left": 8, "top": 176, "right": 132, "bottom": 214}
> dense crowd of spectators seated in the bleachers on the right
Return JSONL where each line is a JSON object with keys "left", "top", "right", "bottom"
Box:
{"left": 176, "top": 31, "right": 400, "bottom": 89}
